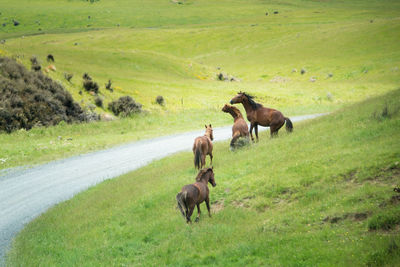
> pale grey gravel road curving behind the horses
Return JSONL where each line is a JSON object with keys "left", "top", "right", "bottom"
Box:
{"left": 0, "top": 114, "right": 324, "bottom": 265}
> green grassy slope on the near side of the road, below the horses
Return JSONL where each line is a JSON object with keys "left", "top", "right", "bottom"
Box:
{"left": 8, "top": 90, "right": 400, "bottom": 266}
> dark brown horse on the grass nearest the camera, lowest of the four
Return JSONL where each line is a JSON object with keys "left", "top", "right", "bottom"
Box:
{"left": 176, "top": 168, "right": 217, "bottom": 223}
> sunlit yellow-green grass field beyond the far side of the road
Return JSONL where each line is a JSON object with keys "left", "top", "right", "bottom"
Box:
{"left": 0, "top": 0, "right": 400, "bottom": 169}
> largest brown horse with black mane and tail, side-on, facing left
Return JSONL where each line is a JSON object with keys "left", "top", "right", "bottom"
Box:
{"left": 230, "top": 92, "right": 293, "bottom": 141}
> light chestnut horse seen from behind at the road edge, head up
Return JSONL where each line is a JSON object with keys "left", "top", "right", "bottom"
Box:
{"left": 192, "top": 124, "right": 214, "bottom": 169}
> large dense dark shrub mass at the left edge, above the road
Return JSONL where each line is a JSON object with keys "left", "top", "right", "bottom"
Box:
{"left": 0, "top": 57, "right": 91, "bottom": 132}
